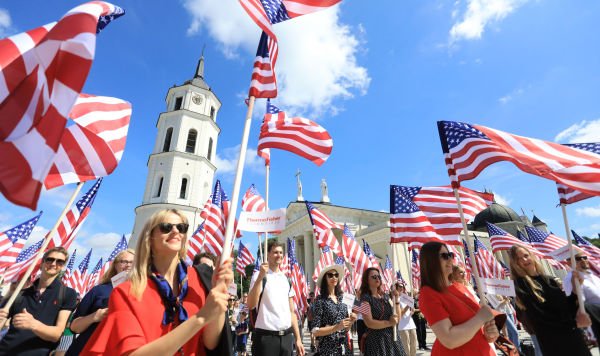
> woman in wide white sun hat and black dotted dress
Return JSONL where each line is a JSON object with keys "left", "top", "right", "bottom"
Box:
{"left": 312, "top": 265, "right": 356, "bottom": 356}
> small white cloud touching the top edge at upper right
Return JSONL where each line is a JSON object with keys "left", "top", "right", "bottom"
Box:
{"left": 450, "top": 0, "right": 528, "bottom": 44}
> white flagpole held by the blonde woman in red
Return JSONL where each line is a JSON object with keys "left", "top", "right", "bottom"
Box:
{"left": 220, "top": 96, "right": 255, "bottom": 264}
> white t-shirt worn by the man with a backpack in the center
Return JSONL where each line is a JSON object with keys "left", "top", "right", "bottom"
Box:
{"left": 250, "top": 269, "right": 296, "bottom": 331}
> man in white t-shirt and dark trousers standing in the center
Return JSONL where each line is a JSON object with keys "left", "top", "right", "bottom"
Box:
{"left": 248, "top": 241, "right": 304, "bottom": 356}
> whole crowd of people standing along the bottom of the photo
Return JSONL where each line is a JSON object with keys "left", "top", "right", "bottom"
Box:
{"left": 0, "top": 210, "right": 600, "bottom": 356}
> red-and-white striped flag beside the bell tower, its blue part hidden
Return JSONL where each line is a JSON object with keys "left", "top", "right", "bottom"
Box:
{"left": 44, "top": 94, "right": 131, "bottom": 189}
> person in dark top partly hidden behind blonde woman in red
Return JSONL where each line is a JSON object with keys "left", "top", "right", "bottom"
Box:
{"left": 66, "top": 249, "right": 135, "bottom": 356}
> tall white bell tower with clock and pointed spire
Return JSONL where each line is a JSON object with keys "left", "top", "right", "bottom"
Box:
{"left": 129, "top": 56, "right": 221, "bottom": 247}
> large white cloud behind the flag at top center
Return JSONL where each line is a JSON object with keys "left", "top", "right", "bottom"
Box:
{"left": 184, "top": 0, "right": 370, "bottom": 114}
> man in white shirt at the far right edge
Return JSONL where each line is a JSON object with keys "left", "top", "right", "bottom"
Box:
{"left": 563, "top": 253, "right": 600, "bottom": 340}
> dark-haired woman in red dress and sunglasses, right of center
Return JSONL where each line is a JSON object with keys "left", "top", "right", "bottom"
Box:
{"left": 419, "top": 242, "right": 498, "bottom": 356}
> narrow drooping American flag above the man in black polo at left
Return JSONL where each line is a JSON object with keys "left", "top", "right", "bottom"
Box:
{"left": 48, "top": 178, "right": 102, "bottom": 249}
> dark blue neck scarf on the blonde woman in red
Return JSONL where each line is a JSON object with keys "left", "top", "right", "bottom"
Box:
{"left": 150, "top": 260, "right": 188, "bottom": 325}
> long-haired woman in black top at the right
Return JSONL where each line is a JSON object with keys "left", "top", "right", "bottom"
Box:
{"left": 509, "top": 245, "right": 591, "bottom": 356}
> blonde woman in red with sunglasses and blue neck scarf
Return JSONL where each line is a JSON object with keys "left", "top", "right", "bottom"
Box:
{"left": 82, "top": 209, "right": 233, "bottom": 355}
